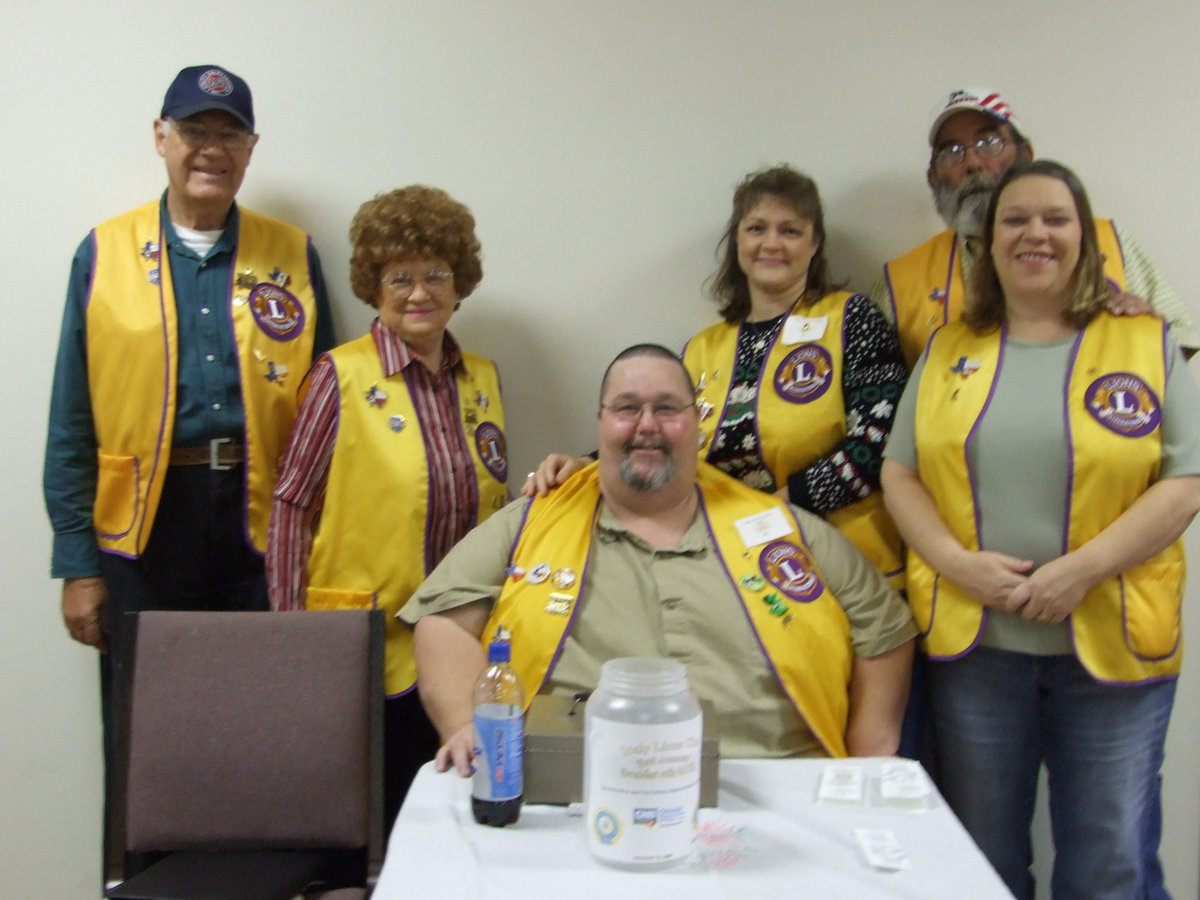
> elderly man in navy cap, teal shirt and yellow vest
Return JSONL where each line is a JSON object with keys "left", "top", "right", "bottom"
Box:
{"left": 43, "top": 65, "right": 334, "bottom": 888}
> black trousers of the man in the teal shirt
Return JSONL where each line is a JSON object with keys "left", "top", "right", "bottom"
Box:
{"left": 100, "top": 466, "right": 268, "bottom": 877}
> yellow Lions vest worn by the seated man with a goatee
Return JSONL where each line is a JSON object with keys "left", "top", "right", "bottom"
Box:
{"left": 484, "top": 463, "right": 853, "bottom": 756}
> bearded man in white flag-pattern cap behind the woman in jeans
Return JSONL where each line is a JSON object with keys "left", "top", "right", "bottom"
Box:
{"left": 871, "top": 88, "right": 1200, "bottom": 368}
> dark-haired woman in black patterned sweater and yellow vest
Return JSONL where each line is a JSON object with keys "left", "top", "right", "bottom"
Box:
{"left": 683, "top": 166, "right": 907, "bottom": 587}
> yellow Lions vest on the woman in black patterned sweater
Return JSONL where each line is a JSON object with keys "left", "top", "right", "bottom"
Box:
{"left": 683, "top": 290, "right": 904, "bottom": 589}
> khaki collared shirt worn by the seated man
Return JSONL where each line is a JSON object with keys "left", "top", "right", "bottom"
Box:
{"left": 400, "top": 499, "right": 917, "bottom": 757}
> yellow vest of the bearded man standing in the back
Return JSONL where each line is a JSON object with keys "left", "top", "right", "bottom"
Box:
{"left": 883, "top": 218, "right": 1126, "bottom": 370}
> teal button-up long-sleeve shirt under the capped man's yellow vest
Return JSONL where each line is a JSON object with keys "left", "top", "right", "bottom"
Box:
{"left": 42, "top": 194, "right": 334, "bottom": 578}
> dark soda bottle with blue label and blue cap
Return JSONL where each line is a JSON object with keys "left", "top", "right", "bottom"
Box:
{"left": 470, "top": 629, "right": 524, "bottom": 828}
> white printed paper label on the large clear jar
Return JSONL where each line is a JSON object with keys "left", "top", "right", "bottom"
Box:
{"left": 586, "top": 715, "right": 701, "bottom": 866}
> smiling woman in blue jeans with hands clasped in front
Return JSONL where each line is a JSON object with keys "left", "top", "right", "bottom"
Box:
{"left": 883, "top": 161, "right": 1200, "bottom": 898}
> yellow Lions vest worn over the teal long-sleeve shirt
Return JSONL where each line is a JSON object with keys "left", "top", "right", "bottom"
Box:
{"left": 86, "top": 200, "right": 317, "bottom": 557}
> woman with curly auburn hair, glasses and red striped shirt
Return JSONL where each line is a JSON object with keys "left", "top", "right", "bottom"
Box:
{"left": 266, "top": 185, "right": 508, "bottom": 829}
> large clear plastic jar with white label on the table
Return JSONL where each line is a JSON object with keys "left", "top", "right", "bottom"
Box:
{"left": 583, "top": 656, "right": 702, "bottom": 870}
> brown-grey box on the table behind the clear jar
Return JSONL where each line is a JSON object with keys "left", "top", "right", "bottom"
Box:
{"left": 524, "top": 694, "right": 721, "bottom": 806}
